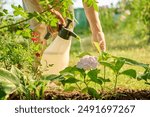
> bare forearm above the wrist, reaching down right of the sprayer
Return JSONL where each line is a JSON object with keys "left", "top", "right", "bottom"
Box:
{"left": 83, "top": 3, "right": 102, "bottom": 33}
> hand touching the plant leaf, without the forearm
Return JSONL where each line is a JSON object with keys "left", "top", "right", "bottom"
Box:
{"left": 92, "top": 31, "right": 106, "bottom": 51}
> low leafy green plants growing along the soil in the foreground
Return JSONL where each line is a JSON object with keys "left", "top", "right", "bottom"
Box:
{"left": 0, "top": 52, "right": 150, "bottom": 99}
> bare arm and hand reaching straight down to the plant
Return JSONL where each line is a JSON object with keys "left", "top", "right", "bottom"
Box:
{"left": 83, "top": 3, "right": 106, "bottom": 51}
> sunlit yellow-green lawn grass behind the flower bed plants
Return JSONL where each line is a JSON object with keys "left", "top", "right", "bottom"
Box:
{"left": 70, "top": 32, "right": 150, "bottom": 90}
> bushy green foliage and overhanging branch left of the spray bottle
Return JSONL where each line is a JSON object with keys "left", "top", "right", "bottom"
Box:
{"left": 0, "top": 0, "right": 76, "bottom": 72}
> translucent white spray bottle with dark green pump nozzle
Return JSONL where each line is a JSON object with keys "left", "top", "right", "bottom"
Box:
{"left": 41, "top": 19, "right": 77, "bottom": 74}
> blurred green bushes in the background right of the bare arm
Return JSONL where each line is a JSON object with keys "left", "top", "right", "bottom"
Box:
{"left": 99, "top": 0, "right": 150, "bottom": 39}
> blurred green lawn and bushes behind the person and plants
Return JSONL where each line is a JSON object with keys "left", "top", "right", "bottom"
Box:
{"left": 70, "top": 0, "right": 150, "bottom": 89}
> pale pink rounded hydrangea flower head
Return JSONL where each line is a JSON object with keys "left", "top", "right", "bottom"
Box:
{"left": 77, "top": 55, "right": 99, "bottom": 70}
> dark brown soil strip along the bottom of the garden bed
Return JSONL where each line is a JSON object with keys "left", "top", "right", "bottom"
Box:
{"left": 8, "top": 88, "right": 150, "bottom": 100}
